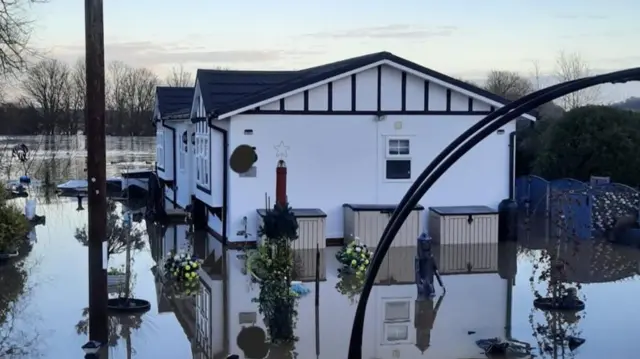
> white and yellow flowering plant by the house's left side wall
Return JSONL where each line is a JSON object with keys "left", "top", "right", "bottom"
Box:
{"left": 164, "top": 251, "right": 201, "bottom": 296}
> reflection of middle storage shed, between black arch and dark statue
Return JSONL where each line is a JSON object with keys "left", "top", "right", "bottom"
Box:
{"left": 375, "top": 246, "right": 416, "bottom": 285}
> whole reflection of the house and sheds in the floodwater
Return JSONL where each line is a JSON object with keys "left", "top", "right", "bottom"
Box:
{"left": 154, "top": 226, "right": 516, "bottom": 359}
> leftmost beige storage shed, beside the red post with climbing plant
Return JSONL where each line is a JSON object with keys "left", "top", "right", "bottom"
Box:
{"left": 257, "top": 208, "right": 327, "bottom": 250}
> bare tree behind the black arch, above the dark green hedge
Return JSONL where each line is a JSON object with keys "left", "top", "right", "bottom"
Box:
{"left": 555, "top": 52, "right": 600, "bottom": 111}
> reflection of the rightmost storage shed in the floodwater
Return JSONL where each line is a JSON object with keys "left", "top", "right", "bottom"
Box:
{"left": 433, "top": 242, "right": 498, "bottom": 275}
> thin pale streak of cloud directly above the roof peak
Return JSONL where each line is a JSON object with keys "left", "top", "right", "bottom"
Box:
{"left": 306, "top": 24, "right": 458, "bottom": 39}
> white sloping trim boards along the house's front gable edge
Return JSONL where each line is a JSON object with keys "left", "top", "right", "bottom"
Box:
{"left": 218, "top": 60, "right": 536, "bottom": 121}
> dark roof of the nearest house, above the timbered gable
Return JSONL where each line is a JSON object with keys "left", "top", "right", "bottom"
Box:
{"left": 197, "top": 52, "right": 536, "bottom": 116}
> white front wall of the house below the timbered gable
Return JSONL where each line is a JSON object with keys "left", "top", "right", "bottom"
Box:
{"left": 228, "top": 114, "right": 514, "bottom": 241}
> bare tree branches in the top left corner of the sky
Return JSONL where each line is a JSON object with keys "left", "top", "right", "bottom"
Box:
{"left": 0, "top": 0, "right": 46, "bottom": 75}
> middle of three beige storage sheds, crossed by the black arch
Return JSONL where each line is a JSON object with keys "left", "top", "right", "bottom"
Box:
{"left": 342, "top": 203, "right": 424, "bottom": 247}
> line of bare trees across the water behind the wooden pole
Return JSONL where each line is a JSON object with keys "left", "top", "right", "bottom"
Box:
{"left": 0, "top": 59, "right": 193, "bottom": 136}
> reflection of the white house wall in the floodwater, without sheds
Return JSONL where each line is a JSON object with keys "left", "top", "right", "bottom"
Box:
{"left": 222, "top": 252, "right": 507, "bottom": 359}
